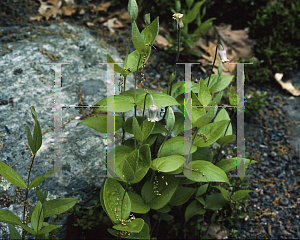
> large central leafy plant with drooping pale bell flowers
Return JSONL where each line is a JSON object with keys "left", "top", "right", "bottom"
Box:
{"left": 69, "top": 0, "right": 256, "bottom": 239}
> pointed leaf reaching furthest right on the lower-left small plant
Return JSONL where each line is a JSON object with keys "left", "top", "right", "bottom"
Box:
{"left": 43, "top": 198, "right": 78, "bottom": 218}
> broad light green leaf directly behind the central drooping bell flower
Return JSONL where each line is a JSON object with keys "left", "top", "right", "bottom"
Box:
{"left": 136, "top": 93, "right": 178, "bottom": 109}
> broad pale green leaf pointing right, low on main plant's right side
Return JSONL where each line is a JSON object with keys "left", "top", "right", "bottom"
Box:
{"left": 187, "top": 160, "right": 229, "bottom": 184}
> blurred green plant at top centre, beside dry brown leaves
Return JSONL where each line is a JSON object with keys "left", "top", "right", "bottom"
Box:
{"left": 165, "top": 0, "right": 216, "bottom": 57}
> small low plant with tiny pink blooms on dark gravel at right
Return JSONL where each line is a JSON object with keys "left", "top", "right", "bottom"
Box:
{"left": 245, "top": 91, "right": 268, "bottom": 117}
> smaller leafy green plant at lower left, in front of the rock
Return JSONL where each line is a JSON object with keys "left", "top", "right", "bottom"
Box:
{"left": 0, "top": 106, "right": 78, "bottom": 240}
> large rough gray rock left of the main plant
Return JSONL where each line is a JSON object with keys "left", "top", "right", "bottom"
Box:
{"left": 0, "top": 23, "right": 134, "bottom": 239}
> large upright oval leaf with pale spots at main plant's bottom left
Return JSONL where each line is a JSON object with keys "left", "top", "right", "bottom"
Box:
{"left": 103, "top": 178, "right": 131, "bottom": 223}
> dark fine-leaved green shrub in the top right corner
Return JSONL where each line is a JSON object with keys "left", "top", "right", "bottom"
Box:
{"left": 207, "top": 0, "right": 300, "bottom": 83}
